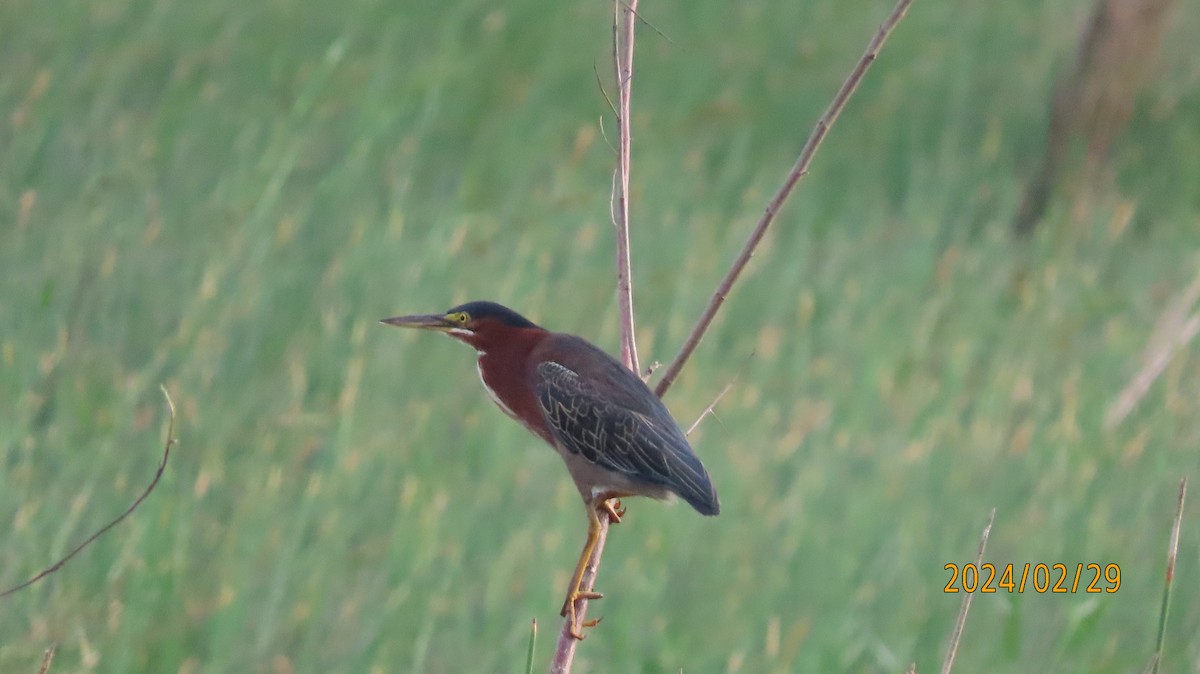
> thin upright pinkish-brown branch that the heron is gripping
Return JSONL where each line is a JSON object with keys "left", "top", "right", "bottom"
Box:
{"left": 550, "top": 0, "right": 641, "bottom": 674}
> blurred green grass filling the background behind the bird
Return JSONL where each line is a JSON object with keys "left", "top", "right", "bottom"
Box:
{"left": 0, "top": 0, "right": 1200, "bottom": 674}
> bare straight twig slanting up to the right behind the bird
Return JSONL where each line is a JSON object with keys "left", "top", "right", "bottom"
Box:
{"left": 654, "top": 0, "right": 912, "bottom": 398}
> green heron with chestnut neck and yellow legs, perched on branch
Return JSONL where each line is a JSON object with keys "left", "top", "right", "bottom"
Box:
{"left": 383, "top": 302, "right": 720, "bottom": 639}
